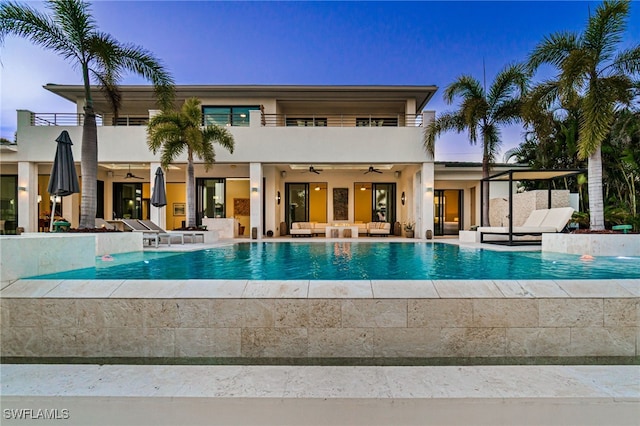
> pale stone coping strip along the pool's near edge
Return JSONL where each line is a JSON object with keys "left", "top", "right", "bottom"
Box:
{"left": 0, "top": 279, "right": 640, "bottom": 299}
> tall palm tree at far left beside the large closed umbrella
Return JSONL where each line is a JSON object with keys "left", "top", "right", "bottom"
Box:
{"left": 0, "top": 0, "right": 174, "bottom": 228}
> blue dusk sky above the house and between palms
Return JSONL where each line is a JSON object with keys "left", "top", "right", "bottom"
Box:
{"left": 0, "top": 1, "right": 640, "bottom": 161}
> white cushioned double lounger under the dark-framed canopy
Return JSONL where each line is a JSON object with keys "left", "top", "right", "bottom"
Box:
{"left": 478, "top": 207, "right": 574, "bottom": 245}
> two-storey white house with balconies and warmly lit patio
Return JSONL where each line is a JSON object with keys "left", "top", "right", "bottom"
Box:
{"left": 0, "top": 84, "right": 500, "bottom": 238}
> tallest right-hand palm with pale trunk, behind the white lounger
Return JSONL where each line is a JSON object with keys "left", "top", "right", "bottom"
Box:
{"left": 528, "top": 0, "right": 640, "bottom": 230}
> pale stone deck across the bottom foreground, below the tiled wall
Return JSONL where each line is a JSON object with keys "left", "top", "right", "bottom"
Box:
{"left": 0, "top": 364, "right": 640, "bottom": 426}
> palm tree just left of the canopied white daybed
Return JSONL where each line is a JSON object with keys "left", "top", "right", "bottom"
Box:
{"left": 423, "top": 65, "right": 528, "bottom": 226}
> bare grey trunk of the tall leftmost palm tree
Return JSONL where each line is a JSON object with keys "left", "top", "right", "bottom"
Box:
{"left": 80, "top": 107, "right": 98, "bottom": 228}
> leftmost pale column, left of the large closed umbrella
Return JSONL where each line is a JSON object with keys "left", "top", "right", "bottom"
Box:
{"left": 17, "top": 161, "right": 38, "bottom": 232}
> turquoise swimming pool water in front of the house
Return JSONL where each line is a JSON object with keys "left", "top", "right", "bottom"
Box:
{"left": 33, "top": 242, "right": 640, "bottom": 280}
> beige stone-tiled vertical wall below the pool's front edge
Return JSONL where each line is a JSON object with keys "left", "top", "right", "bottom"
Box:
{"left": 0, "top": 296, "right": 640, "bottom": 358}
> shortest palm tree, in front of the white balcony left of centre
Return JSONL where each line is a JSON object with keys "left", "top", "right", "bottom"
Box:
{"left": 147, "top": 98, "right": 234, "bottom": 227}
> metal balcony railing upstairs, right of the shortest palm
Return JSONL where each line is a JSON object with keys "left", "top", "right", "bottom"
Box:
{"left": 262, "top": 114, "right": 422, "bottom": 127}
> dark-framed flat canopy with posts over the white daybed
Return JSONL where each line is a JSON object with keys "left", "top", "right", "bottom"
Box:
{"left": 480, "top": 169, "right": 587, "bottom": 246}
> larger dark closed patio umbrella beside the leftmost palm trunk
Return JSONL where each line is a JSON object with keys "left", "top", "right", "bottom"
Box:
{"left": 47, "top": 130, "right": 80, "bottom": 231}
